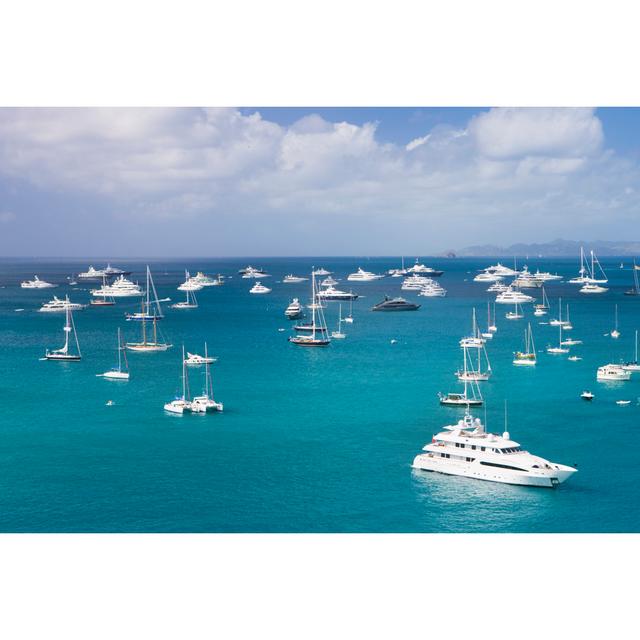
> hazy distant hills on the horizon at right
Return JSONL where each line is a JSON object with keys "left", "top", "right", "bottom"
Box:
{"left": 455, "top": 239, "right": 640, "bottom": 257}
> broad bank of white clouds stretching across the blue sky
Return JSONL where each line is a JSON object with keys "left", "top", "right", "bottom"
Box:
{"left": 0, "top": 108, "right": 640, "bottom": 246}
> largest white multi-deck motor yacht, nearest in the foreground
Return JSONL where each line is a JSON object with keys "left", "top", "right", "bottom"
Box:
{"left": 412, "top": 413, "right": 577, "bottom": 488}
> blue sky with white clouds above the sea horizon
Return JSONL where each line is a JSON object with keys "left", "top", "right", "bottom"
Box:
{"left": 0, "top": 107, "right": 640, "bottom": 257}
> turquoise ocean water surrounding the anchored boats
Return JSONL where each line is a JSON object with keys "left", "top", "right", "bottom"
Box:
{"left": 0, "top": 258, "right": 640, "bottom": 532}
